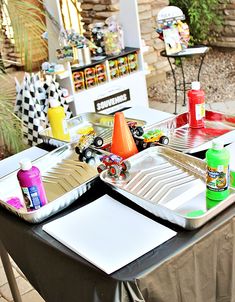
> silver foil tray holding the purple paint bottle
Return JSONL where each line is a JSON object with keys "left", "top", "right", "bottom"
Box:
{"left": 0, "top": 144, "right": 98, "bottom": 223}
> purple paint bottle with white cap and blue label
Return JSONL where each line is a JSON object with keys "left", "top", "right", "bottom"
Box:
{"left": 17, "top": 159, "right": 47, "bottom": 211}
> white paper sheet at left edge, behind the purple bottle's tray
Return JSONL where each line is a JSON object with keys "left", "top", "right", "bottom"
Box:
{"left": 0, "top": 147, "right": 48, "bottom": 178}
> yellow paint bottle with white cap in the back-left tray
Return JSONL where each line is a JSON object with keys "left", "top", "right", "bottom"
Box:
{"left": 47, "top": 99, "right": 70, "bottom": 141}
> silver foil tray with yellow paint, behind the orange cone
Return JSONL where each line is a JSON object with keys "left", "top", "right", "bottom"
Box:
{"left": 39, "top": 112, "right": 146, "bottom": 147}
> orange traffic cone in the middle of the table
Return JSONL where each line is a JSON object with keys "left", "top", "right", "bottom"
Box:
{"left": 111, "top": 112, "right": 138, "bottom": 159}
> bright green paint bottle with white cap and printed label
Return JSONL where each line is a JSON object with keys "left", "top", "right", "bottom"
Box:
{"left": 206, "top": 140, "right": 229, "bottom": 200}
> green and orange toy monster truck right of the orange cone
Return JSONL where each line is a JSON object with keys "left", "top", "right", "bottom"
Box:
{"left": 142, "top": 129, "right": 169, "bottom": 149}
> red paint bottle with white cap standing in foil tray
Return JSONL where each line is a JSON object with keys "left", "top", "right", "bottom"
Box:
{"left": 188, "top": 82, "right": 205, "bottom": 128}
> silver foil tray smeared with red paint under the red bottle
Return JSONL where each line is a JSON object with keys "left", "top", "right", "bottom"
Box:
{"left": 146, "top": 110, "right": 235, "bottom": 153}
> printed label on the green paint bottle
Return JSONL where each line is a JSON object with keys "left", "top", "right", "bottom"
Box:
{"left": 206, "top": 165, "right": 229, "bottom": 192}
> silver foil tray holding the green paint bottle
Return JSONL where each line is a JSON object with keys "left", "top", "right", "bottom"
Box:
{"left": 100, "top": 147, "right": 235, "bottom": 230}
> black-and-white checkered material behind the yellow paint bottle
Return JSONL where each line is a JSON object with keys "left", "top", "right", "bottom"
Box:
{"left": 14, "top": 73, "right": 72, "bottom": 146}
